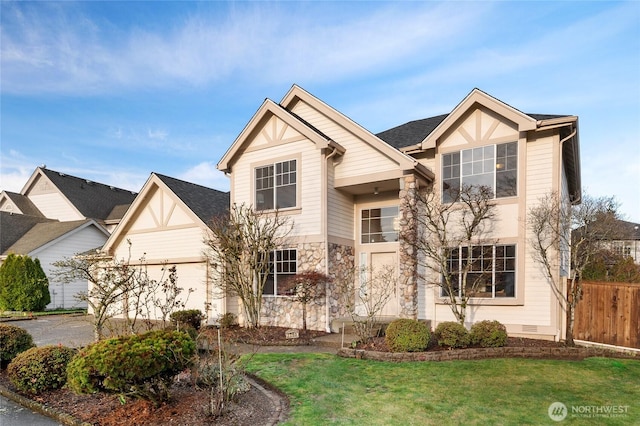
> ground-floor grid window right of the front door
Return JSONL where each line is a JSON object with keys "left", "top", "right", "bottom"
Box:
{"left": 441, "top": 245, "right": 516, "bottom": 298}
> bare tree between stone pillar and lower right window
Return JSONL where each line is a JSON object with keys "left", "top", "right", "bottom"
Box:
{"left": 402, "top": 185, "right": 496, "bottom": 325}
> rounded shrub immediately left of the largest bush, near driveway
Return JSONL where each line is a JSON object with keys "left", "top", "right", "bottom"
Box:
{"left": 7, "top": 346, "right": 76, "bottom": 395}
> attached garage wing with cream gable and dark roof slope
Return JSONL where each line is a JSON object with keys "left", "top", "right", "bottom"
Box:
{"left": 102, "top": 173, "right": 230, "bottom": 320}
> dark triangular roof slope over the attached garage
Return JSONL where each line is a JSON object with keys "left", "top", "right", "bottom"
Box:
{"left": 154, "top": 173, "right": 229, "bottom": 224}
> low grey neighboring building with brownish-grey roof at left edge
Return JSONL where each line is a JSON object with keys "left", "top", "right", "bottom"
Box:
{"left": 0, "top": 211, "right": 109, "bottom": 309}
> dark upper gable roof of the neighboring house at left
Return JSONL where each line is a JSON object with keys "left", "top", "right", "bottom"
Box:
{"left": 22, "top": 167, "right": 136, "bottom": 220}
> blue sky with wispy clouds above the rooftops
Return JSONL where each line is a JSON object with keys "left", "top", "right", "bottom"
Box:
{"left": 0, "top": 0, "right": 640, "bottom": 222}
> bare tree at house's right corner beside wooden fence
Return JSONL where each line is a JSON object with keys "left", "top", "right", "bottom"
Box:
{"left": 527, "top": 192, "right": 618, "bottom": 345}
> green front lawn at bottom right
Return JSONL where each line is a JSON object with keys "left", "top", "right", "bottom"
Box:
{"left": 247, "top": 354, "right": 640, "bottom": 425}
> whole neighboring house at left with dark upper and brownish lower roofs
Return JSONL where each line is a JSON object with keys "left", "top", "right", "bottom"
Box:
{"left": 0, "top": 166, "right": 136, "bottom": 309}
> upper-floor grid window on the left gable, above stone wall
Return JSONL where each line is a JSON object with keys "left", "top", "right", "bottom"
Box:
{"left": 255, "top": 160, "right": 297, "bottom": 210}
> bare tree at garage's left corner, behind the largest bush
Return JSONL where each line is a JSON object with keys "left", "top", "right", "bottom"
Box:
{"left": 53, "top": 245, "right": 136, "bottom": 341}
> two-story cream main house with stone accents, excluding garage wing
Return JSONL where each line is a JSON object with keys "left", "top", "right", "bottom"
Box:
{"left": 217, "top": 85, "right": 581, "bottom": 340}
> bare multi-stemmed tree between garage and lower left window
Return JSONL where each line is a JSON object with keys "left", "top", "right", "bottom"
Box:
{"left": 204, "top": 204, "right": 293, "bottom": 328}
